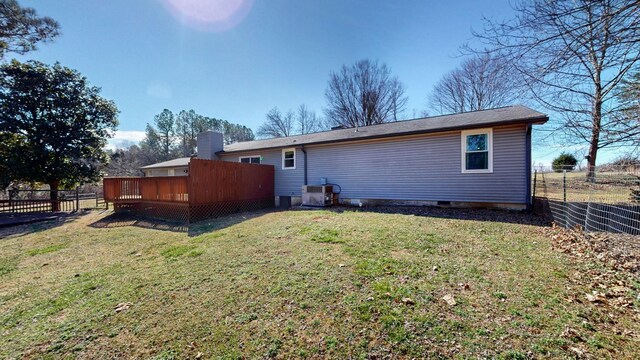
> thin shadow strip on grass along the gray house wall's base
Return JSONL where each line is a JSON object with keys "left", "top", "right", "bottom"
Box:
{"left": 300, "top": 206, "right": 551, "bottom": 226}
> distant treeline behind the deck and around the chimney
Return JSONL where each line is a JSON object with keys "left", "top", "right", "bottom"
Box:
{"left": 105, "top": 109, "right": 255, "bottom": 176}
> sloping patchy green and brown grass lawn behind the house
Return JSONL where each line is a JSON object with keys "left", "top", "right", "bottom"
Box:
{"left": 0, "top": 211, "right": 640, "bottom": 359}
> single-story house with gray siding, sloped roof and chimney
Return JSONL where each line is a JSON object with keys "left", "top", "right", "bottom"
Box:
{"left": 142, "top": 105, "right": 549, "bottom": 209}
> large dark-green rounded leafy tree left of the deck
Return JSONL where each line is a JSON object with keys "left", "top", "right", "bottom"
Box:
{"left": 0, "top": 60, "right": 118, "bottom": 208}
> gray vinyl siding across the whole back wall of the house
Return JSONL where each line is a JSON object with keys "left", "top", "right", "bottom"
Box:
{"left": 220, "top": 125, "right": 527, "bottom": 204}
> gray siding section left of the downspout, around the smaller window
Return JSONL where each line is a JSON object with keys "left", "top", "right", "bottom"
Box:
{"left": 219, "top": 149, "right": 304, "bottom": 196}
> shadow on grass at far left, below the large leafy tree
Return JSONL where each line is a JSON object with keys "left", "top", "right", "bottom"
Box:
{"left": 0, "top": 211, "right": 88, "bottom": 239}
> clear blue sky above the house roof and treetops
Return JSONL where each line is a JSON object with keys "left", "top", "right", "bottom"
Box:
{"left": 18, "top": 0, "right": 620, "bottom": 163}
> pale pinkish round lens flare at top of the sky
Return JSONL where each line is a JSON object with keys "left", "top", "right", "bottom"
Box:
{"left": 164, "top": 0, "right": 253, "bottom": 31}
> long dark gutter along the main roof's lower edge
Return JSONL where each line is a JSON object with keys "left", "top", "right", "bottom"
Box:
{"left": 216, "top": 116, "right": 549, "bottom": 155}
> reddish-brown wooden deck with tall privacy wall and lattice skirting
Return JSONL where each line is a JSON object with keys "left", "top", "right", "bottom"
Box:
{"left": 104, "top": 159, "right": 274, "bottom": 222}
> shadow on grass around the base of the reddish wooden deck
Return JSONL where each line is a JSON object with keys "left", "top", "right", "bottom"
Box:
{"left": 89, "top": 209, "right": 274, "bottom": 237}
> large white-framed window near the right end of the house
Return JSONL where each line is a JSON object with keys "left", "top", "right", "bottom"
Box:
{"left": 462, "top": 129, "right": 493, "bottom": 173}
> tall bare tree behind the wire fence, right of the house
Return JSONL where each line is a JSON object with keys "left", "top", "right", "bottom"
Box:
{"left": 468, "top": 0, "right": 640, "bottom": 178}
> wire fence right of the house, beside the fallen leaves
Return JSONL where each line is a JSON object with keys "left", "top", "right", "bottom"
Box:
{"left": 533, "top": 165, "right": 640, "bottom": 235}
